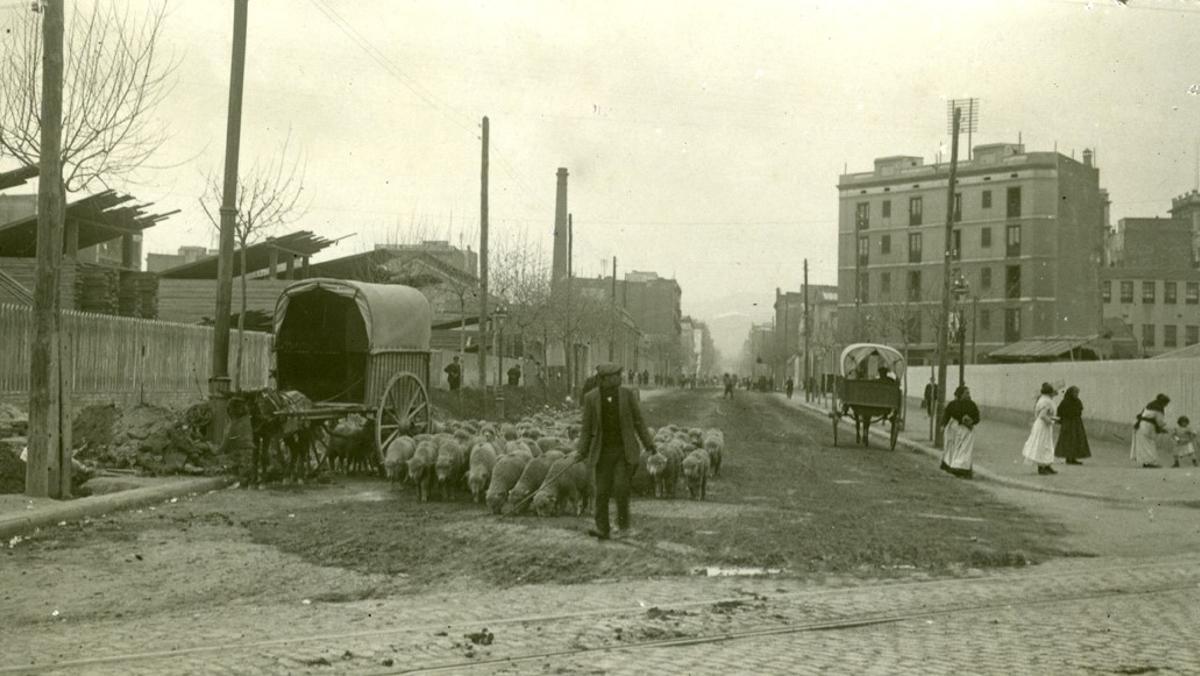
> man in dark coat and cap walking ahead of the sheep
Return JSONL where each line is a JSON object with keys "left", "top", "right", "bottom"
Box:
{"left": 575, "top": 364, "right": 654, "bottom": 540}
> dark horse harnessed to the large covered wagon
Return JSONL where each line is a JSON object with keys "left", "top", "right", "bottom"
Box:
{"left": 241, "top": 388, "right": 313, "bottom": 483}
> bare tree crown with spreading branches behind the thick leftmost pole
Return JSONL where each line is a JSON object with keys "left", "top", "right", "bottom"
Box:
{"left": 0, "top": 1, "right": 179, "bottom": 192}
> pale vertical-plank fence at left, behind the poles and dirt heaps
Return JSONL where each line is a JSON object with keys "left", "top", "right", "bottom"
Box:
{"left": 0, "top": 304, "right": 271, "bottom": 405}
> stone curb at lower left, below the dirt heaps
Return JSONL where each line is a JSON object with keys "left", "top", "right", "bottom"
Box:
{"left": 0, "top": 477, "right": 233, "bottom": 539}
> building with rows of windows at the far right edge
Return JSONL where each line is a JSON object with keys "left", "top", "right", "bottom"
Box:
{"left": 1100, "top": 211, "right": 1200, "bottom": 357}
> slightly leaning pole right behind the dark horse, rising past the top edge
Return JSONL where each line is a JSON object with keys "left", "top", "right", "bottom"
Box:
{"left": 209, "top": 0, "right": 250, "bottom": 441}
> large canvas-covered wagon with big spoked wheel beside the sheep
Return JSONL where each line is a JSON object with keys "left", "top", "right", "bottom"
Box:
{"left": 275, "top": 279, "right": 432, "bottom": 463}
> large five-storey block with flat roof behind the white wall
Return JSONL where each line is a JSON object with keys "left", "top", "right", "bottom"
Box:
{"left": 838, "top": 143, "right": 1108, "bottom": 364}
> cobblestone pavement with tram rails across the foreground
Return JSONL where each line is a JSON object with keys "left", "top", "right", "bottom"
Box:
{"left": 0, "top": 545, "right": 1200, "bottom": 675}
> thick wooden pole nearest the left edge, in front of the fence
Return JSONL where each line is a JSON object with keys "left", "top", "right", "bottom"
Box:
{"left": 25, "top": 0, "right": 71, "bottom": 498}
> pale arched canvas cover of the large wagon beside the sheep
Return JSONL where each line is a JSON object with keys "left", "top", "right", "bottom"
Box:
{"left": 275, "top": 277, "right": 433, "bottom": 354}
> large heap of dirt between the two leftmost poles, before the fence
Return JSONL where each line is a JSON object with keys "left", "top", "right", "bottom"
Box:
{"left": 72, "top": 405, "right": 229, "bottom": 474}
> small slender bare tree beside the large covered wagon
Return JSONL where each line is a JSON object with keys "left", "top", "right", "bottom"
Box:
{"left": 200, "top": 137, "right": 308, "bottom": 390}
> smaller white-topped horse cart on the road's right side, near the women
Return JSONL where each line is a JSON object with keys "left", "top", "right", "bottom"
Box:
{"left": 829, "top": 342, "right": 905, "bottom": 450}
